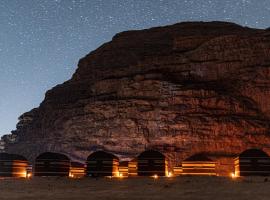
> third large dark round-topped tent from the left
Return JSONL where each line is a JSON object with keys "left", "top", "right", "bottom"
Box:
{"left": 86, "top": 151, "right": 119, "bottom": 177}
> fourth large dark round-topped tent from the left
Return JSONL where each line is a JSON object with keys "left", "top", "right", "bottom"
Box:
{"left": 137, "top": 150, "right": 168, "bottom": 176}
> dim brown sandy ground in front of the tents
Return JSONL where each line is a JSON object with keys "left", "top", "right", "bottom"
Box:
{"left": 0, "top": 177, "right": 270, "bottom": 200}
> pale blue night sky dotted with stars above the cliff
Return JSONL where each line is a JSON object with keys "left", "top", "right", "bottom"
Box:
{"left": 0, "top": 0, "right": 270, "bottom": 136}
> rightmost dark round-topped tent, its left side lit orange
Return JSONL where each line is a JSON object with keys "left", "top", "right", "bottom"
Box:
{"left": 234, "top": 149, "right": 270, "bottom": 176}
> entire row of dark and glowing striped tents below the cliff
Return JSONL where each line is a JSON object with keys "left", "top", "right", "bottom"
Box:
{"left": 0, "top": 149, "right": 270, "bottom": 178}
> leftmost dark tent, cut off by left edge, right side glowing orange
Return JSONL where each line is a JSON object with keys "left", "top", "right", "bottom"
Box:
{"left": 0, "top": 153, "right": 28, "bottom": 178}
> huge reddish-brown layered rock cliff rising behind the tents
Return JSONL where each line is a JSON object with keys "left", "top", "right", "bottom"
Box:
{"left": 5, "top": 22, "right": 270, "bottom": 175}
